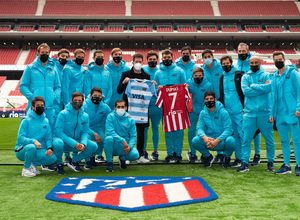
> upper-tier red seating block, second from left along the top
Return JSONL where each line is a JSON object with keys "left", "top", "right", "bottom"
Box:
{"left": 43, "top": 0, "right": 125, "bottom": 17}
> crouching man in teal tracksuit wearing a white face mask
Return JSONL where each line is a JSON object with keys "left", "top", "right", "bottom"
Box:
{"left": 104, "top": 100, "right": 140, "bottom": 172}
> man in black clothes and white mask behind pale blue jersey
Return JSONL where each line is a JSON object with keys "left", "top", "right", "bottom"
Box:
{"left": 117, "top": 54, "right": 150, "bottom": 163}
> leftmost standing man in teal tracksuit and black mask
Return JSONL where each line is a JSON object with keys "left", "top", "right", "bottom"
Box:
{"left": 20, "top": 43, "right": 61, "bottom": 129}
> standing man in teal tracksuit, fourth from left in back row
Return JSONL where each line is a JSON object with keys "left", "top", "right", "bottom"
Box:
{"left": 84, "top": 50, "right": 112, "bottom": 104}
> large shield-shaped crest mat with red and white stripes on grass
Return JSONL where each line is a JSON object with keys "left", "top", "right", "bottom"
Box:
{"left": 46, "top": 177, "right": 218, "bottom": 212}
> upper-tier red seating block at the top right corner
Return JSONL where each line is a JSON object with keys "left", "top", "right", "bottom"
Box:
{"left": 218, "top": 1, "right": 300, "bottom": 16}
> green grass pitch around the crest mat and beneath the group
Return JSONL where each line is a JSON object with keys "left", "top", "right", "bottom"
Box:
{"left": 0, "top": 119, "right": 300, "bottom": 220}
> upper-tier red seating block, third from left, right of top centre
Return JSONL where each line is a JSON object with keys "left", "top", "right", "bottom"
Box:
{"left": 131, "top": 1, "right": 214, "bottom": 16}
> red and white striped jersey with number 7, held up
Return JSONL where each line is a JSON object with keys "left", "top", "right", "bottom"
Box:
{"left": 156, "top": 84, "right": 191, "bottom": 132}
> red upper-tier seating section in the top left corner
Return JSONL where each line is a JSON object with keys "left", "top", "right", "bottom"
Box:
{"left": 0, "top": 0, "right": 38, "bottom": 17}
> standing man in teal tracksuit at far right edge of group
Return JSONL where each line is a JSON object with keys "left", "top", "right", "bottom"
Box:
{"left": 272, "top": 51, "right": 300, "bottom": 176}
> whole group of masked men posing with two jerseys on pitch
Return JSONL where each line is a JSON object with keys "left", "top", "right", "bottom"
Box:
{"left": 15, "top": 43, "right": 300, "bottom": 177}
